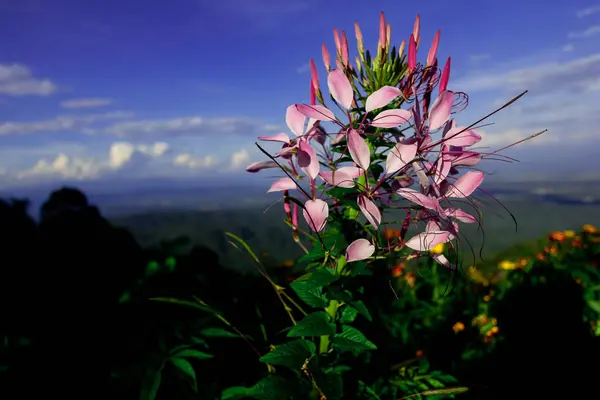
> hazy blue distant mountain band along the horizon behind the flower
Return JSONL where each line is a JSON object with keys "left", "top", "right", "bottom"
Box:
{"left": 0, "top": 175, "right": 600, "bottom": 216}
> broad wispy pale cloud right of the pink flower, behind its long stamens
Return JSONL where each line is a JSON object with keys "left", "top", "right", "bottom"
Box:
{"left": 452, "top": 49, "right": 600, "bottom": 148}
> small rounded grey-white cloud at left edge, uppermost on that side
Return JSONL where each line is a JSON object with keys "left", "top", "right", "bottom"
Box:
{"left": 0, "top": 64, "right": 58, "bottom": 96}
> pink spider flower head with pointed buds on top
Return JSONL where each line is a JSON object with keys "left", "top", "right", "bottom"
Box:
{"left": 247, "top": 13, "right": 524, "bottom": 268}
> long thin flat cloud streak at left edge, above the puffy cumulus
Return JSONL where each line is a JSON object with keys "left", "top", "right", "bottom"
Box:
{"left": 0, "top": 111, "right": 133, "bottom": 136}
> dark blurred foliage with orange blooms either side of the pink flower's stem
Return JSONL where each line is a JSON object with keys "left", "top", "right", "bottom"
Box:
{"left": 0, "top": 188, "right": 600, "bottom": 400}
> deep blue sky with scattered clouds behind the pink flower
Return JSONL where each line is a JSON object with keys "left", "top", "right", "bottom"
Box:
{"left": 0, "top": 0, "right": 600, "bottom": 187}
